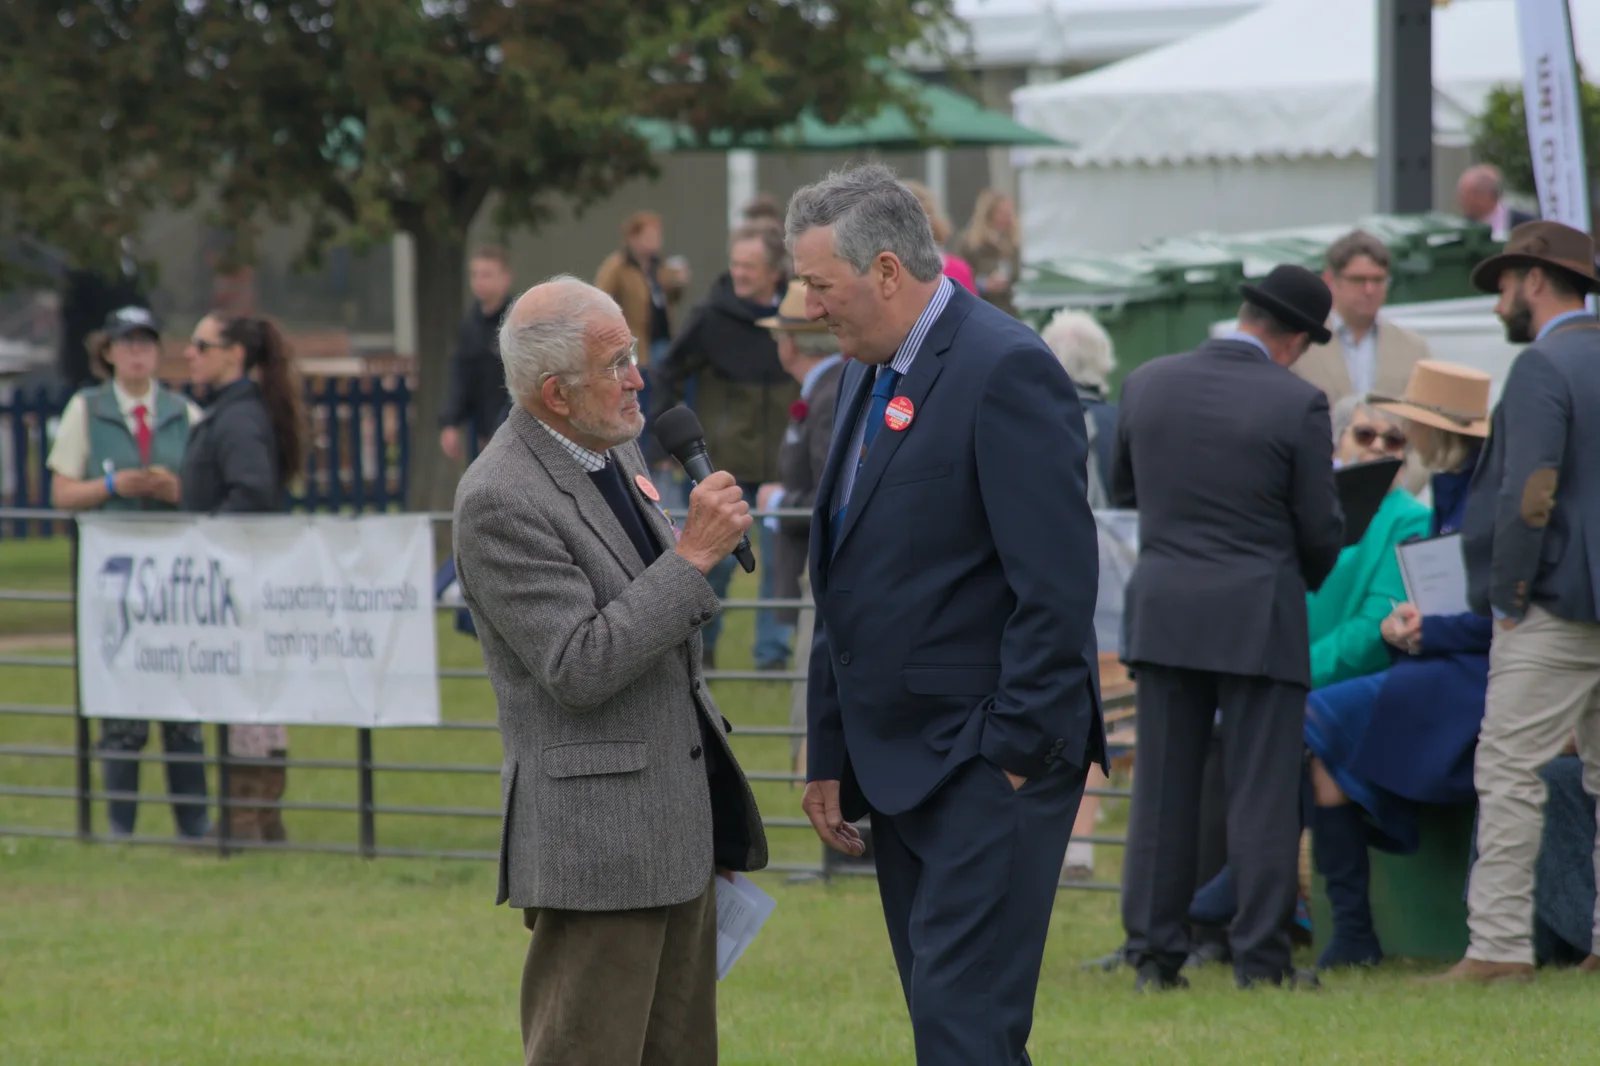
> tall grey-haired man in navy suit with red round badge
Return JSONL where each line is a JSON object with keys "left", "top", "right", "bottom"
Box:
{"left": 787, "top": 166, "right": 1106, "bottom": 1066}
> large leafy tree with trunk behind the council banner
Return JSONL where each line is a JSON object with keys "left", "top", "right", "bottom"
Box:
{"left": 0, "top": 0, "right": 954, "bottom": 506}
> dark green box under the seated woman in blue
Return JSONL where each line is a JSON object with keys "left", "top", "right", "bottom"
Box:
{"left": 1312, "top": 804, "right": 1475, "bottom": 962}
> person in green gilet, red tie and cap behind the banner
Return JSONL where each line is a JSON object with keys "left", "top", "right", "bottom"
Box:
{"left": 46, "top": 307, "right": 210, "bottom": 839}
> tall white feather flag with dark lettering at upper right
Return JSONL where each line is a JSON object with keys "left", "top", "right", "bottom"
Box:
{"left": 1517, "top": 0, "right": 1589, "bottom": 234}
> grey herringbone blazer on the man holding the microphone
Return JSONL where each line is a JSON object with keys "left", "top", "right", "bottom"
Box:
{"left": 454, "top": 408, "right": 766, "bottom": 911}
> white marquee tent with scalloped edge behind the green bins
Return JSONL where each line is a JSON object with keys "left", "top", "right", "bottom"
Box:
{"left": 1013, "top": 0, "right": 1600, "bottom": 261}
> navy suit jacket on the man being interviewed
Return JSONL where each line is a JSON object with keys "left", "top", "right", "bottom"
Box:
{"left": 806, "top": 280, "right": 1106, "bottom": 820}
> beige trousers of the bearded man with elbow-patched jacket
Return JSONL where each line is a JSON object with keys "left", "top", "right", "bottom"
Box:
{"left": 1467, "top": 607, "right": 1600, "bottom": 964}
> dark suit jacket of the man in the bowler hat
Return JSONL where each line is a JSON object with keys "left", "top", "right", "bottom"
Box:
{"left": 1109, "top": 339, "right": 1344, "bottom": 688}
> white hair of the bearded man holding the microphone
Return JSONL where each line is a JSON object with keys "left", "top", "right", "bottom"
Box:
{"left": 499, "top": 274, "right": 622, "bottom": 405}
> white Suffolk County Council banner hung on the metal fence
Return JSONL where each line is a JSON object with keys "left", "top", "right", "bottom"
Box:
{"left": 77, "top": 514, "right": 438, "bottom": 727}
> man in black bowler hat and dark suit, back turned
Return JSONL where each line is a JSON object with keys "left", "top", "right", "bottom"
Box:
{"left": 1110, "top": 266, "right": 1344, "bottom": 989}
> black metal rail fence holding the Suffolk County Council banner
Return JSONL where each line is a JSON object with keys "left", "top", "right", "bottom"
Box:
{"left": 0, "top": 507, "right": 1131, "bottom": 892}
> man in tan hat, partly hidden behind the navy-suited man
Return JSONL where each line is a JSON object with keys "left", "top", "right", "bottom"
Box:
{"left": 755, "top": 282, "right": 845, "bottom": 777}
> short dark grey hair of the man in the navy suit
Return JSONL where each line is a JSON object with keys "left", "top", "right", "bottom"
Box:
{"left": 784, "top": 163, "right": 944, "bottom": 282}
